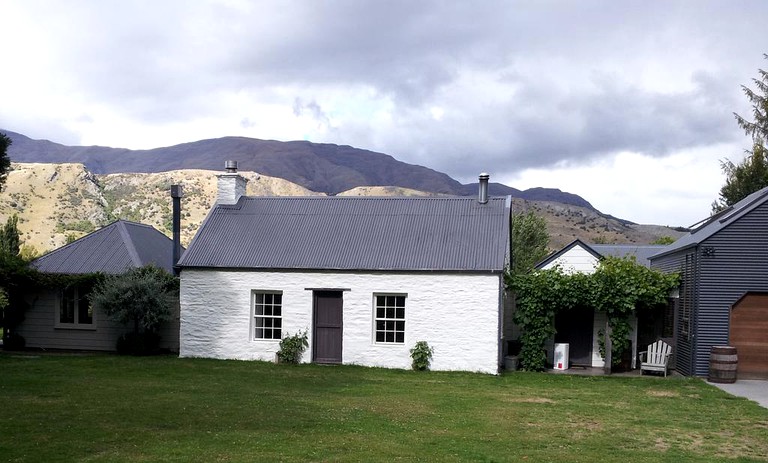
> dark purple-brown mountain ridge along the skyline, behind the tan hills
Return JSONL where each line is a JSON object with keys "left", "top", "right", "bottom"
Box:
{"left": 0, "top": 130, "right": 592, "bottom": 208}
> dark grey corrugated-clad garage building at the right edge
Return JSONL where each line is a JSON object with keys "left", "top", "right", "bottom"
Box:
{"left": 650, "top": 188, "right": 768, "bottom": 376}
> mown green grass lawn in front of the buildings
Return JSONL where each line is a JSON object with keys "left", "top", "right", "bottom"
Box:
{"left": 0, "top": 353, "right": 768, "bottom": 463}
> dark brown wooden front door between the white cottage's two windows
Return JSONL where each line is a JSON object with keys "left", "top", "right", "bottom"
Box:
{"left": 312, "top": 291, "right": 343, "bottom": 363}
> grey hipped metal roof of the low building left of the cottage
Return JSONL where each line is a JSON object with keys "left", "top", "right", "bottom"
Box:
{"left": 30, "top": 220, "right": 173, "bottom": 274}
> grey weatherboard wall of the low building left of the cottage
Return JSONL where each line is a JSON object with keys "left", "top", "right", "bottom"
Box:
{"left": 18, "top": 290, "right": 179, "bottom": 352}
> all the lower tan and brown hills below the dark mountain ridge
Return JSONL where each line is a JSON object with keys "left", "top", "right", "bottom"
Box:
{"left": 0, "top": 163, "right": 680, "bottom": 258}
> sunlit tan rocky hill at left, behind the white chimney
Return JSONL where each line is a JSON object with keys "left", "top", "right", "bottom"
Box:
{"left": 0, "top": 163, "right": 318, "bottom": 252}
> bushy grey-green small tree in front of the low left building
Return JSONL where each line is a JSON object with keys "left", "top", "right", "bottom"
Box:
{"left": 89, "top": 265, "right": 178, "bottom": 354}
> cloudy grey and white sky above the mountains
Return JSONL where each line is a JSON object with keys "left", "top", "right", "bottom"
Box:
{"left": 0, "top": 0, "right": 768, "bottom": 226}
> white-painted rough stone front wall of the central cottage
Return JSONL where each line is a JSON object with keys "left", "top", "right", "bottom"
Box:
{"left": 180, "top": 269, "right": 501, "bottom": 373}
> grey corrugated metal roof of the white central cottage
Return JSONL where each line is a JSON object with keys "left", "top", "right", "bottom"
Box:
{"left": 179, "top": 197, "right": 511, "bottom": 271}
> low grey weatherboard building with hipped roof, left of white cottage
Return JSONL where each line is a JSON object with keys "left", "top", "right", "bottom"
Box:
{"left": 17, "top": 220, "right": 179, "bottom": 351}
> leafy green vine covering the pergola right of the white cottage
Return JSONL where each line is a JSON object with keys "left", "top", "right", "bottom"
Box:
{"left": 507, "top": 257, "right": 678, "bottom": 371}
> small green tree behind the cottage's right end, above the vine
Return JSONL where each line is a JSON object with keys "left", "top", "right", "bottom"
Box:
{"left": 509, "top": 211, "right": 549, "bottom": 274}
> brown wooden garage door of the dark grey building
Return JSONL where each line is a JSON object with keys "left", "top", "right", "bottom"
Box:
{"left": 730, "top": 293, "right": 768, "bottom": 379}
